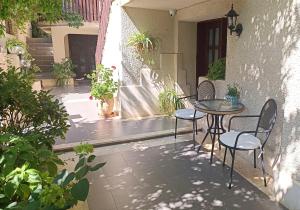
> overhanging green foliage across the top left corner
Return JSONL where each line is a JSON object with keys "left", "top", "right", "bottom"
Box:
{"left": 0, "top": 0, "right": 82, "bottom": 36}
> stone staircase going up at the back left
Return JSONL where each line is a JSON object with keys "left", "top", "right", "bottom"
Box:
{"left": 27, "top": 38, "right": 54, "bottom": 78}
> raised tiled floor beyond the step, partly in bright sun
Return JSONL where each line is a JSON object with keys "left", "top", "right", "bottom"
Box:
{"left": 52, "top": 85, "right": 192, "bottom": 144}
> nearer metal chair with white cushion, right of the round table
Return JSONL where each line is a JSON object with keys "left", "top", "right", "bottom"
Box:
{"left": 220, "top": 99, "right": 277, "bottom": 189}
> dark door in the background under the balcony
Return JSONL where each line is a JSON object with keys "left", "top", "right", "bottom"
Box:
{"left": 68, "top": 34, "right": 97, "bottom": 78}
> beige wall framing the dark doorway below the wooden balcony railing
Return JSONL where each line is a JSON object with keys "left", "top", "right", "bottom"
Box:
{"left": 51, "top": 23, "right": 99, "bottom": 62}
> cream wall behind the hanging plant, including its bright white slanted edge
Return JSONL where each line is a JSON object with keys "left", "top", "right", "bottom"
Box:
{"left": 102, "top": 1, "right": 183, "bottom": 118}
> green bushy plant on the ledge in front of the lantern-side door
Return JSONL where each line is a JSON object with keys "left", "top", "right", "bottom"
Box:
{"left": 207, "top": 58, "right": 226, "bottom": 80}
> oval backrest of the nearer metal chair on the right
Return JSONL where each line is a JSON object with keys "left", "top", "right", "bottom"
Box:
{"left": 256, "top": 99, "right": 277, "bottom": 146}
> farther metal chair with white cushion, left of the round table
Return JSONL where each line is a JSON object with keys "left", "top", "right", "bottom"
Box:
{"left": 175, "top": 80, "right": 216, "bottom": 147}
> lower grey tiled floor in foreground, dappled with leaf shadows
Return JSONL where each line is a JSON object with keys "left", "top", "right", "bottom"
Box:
{"left": 82, "top": 135, "right": 283, "bottom": 210}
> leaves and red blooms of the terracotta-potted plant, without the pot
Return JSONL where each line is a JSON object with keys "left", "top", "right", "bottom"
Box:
{"left": 87, "top": 64, "right": 118, "bottom": 101}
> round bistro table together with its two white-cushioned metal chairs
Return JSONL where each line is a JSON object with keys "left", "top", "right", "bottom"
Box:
{"left": 175, "top": 80, "right": 277, "bottom": 189}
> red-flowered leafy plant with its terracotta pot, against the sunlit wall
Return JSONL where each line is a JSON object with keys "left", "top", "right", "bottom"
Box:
{"left": 87, "top": 64, "right": 118, "bottom": 118}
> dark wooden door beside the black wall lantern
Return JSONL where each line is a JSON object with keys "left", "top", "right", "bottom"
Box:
{"left": 196, "top": 18, "right": 227, "bottom": 81}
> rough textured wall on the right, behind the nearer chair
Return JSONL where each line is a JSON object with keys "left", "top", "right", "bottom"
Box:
{"left": 226, "top": 0, "right": 300, "bottom": 209}
